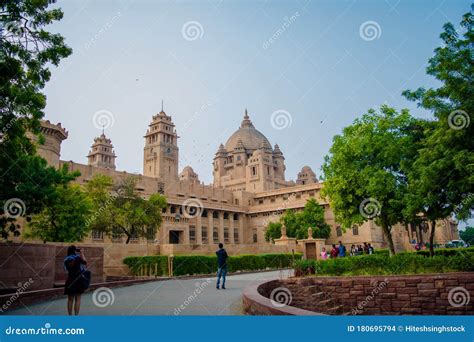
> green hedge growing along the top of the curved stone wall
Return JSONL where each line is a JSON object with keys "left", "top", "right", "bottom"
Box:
{"left": 295, "top": 252, "right": 474, "bottom": 276}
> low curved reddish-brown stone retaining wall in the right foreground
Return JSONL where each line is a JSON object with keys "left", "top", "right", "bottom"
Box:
{"left": 244, "top": 272, "right": 474, "bottom": 315}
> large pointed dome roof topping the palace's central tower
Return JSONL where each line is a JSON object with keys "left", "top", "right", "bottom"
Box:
{"left": 225, "top": 110, "right": 272, "bottom": 152}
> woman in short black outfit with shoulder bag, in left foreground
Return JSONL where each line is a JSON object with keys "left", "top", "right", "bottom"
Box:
{"left": 64, "top": 246, "right": 87, "bottom": 316}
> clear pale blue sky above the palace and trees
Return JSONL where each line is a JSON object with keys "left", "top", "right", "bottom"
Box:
{"left": 46, "top": 0, "right": 470, "bottom": 227}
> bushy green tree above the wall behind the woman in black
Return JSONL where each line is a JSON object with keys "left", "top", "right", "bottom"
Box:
{"left": 25, "top": 184, "right": 91, "bottom": 242}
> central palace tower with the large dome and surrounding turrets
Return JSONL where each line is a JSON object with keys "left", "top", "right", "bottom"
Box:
{"left": 214, "top": 110, "right": 288, "bottom": 192}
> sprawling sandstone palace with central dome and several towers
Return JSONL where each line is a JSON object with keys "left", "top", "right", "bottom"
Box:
{"left": 26, "top": 111, "right": 458, "bottom": 273}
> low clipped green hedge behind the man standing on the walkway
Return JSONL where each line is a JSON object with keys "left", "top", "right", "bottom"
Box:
{"left": 123, "top": 253, "right": 302, "bottom": 276}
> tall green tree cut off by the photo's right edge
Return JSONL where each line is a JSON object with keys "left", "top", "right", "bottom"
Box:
{"left": 403, "top": 6, "right": 474, "bottom": 255}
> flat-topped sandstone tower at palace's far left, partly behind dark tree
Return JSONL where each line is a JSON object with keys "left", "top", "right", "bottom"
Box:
{"left": 27, "top": 120, "right": 68, "bottom": 168}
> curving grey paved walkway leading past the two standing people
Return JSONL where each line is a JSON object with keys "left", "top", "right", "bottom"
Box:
{"left": 6, "top": 270, "right": 290, "bottom": 315}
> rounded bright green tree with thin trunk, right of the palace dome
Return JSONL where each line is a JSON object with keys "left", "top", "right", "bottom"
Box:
{"left": 322, "top": 105, "right": 416, "bottom": 255}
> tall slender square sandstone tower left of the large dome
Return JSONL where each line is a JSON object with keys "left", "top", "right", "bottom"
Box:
{"left": 143, "top": 108, "right": 179, "bottom": 181}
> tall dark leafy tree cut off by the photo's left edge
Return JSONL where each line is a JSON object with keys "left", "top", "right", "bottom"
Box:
{"left": 0, "top": 0, "right": 73, "bottom": 239}
